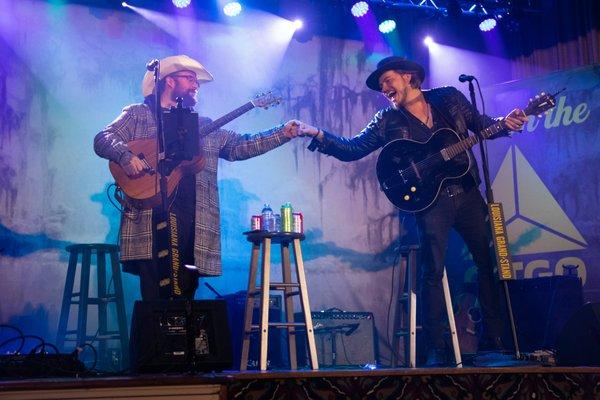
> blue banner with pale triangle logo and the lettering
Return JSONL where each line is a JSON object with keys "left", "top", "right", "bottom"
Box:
{"left": 485, "top": 65, "right": 600, "bottom": 301}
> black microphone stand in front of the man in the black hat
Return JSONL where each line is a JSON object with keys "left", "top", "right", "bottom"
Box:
{"left": 468, "top": 77, "right": 521, "bottom": 359}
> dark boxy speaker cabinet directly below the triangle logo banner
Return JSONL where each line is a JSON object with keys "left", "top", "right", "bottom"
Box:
{"left": 508, "top": 276, "right": 583, "bottom": 352}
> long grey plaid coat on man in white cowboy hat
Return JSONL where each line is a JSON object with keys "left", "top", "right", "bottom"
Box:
{"left": 94, "top": 104, "right": 289, "bottom": 276}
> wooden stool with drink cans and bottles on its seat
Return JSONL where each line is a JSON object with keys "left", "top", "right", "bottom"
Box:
{"left": 240, "top": 231, "right": 319, "bottom": 371}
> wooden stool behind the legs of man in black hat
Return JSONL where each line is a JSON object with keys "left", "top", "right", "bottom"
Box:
{"left": 392, "top": 245, "right": 462, "bottom": 368}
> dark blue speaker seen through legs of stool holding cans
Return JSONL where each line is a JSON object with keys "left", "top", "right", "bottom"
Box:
{"left": 223, "top": 290, "right": 288, "bottom": 369}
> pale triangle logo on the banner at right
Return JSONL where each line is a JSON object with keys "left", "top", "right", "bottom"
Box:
{"left": 492, "top": 145, "right": 587, "bottom": 255}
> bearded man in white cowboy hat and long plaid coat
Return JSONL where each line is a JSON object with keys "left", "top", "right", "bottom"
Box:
{"left": 94, "top": 55, "right": 298, "bottom": 300}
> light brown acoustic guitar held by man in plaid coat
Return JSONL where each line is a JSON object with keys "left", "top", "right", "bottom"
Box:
{"left": 108, "top": 92, "right": 281, "bottom": 209}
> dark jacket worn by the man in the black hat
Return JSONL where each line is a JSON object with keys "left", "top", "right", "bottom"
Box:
{"left": 308, "top": 86, "right": 508, "bottom": 185}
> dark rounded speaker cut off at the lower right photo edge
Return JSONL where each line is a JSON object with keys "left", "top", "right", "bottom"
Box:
{"left": 556, "top": 303, "right": 600, "bottom": 367}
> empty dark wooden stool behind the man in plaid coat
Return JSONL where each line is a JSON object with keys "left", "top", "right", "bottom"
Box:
{"left": 56, "top": 243, "right": 129, "bottom": 366}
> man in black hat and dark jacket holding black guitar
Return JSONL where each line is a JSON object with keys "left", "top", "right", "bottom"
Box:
{"left": 300, "top": 57, "right": 527, "bottom": 366}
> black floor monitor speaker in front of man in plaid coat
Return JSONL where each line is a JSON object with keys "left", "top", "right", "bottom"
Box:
{"left": 129, "top": 300, "right": 232, "bottom": 372}
